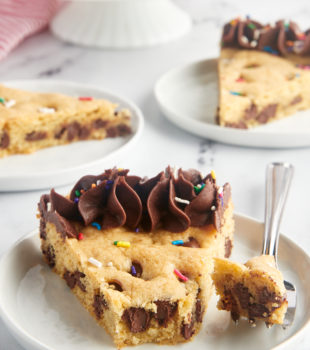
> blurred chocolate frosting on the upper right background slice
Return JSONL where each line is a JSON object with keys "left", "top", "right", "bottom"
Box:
{"left": 222, "top": 18, "right": 310, "bottom": 56}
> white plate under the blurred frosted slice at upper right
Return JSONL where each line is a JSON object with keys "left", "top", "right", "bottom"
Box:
{"left": 154, "top": 59, "right": 310, "bottom": 148}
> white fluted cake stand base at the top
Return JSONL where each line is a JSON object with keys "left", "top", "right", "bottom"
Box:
{"left": 50, "top": 0, "right": 191, "bottom": 49}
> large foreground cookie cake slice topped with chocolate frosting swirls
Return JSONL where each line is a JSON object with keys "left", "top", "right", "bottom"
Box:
{"left": 39, "top": 167, "right": 234, "bottom": 348}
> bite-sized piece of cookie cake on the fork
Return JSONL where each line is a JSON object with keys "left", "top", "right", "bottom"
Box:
{"left": 212, "top": 255, "right": 287, "bottom": 326}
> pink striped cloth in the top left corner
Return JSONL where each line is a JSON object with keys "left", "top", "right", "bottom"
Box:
{"left": 0, "top": 0, "right": 59, "bottom": 60}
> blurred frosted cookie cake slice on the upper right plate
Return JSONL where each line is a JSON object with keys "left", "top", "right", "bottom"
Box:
{"left": 217, "top": 18, "right": 310, "bottom": 129}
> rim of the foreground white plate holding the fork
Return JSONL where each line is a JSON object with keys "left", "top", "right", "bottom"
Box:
{"left": 0, "top": 213, "right": 310, "bottom": 350}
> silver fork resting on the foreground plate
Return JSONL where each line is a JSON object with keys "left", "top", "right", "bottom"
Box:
{"left": 262, "top": 163, "right": 297, "bottom": 328}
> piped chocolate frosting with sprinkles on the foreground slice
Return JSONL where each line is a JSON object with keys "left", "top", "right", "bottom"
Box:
{"left": 39, "top": 167, "right": 231, "bottom": 237}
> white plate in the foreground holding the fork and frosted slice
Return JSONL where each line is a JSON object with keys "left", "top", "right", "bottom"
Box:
{"left": 0, "top": 215, "right": 310, "bottom": 350}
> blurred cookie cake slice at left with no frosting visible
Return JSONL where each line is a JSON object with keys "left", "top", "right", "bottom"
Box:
{"left": 0, "top": 85, "right": 131, "bottom": 158}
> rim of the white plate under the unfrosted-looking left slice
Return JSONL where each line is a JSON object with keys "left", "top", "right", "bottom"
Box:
{"left": 0, "top": 79, "right": 145, "bottom": 183}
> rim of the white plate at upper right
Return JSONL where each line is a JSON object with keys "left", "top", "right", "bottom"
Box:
{"left": 153, "top": 57, "right": 310, "bottom": 149}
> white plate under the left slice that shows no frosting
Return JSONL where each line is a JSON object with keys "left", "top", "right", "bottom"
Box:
{"left": 0, "top": 80, "right": 144, "bottom": 191}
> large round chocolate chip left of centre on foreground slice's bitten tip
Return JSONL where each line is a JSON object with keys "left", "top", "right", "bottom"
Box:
{"left": 122, "top": 307, "right": 151, "bottom": 333}
